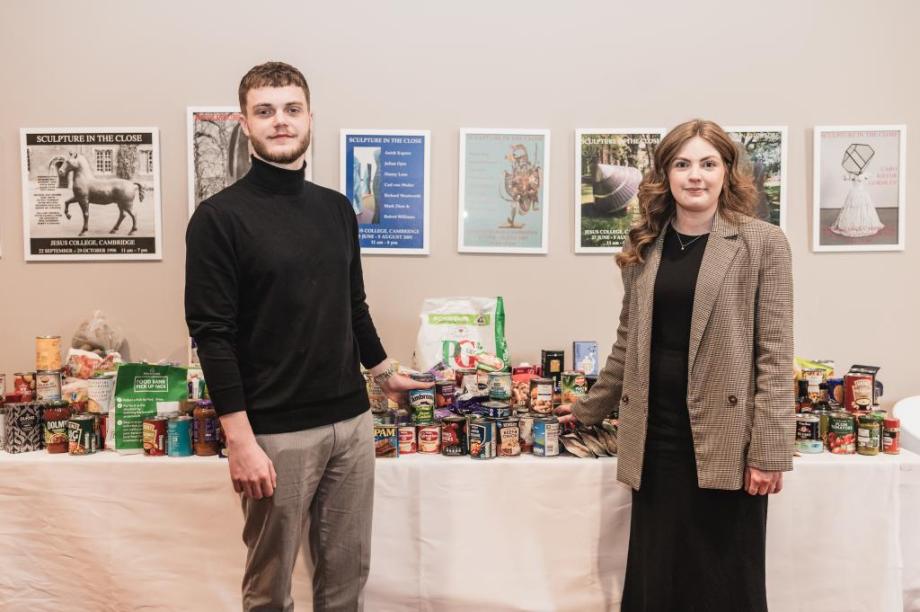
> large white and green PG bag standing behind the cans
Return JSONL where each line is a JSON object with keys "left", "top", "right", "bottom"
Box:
{"left": 415, "top": 297, "right": 510, "bottom": 371}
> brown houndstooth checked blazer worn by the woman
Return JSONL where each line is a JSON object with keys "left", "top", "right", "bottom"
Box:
{"left": 573, "top": 214, "right": 795, "bottom": 490}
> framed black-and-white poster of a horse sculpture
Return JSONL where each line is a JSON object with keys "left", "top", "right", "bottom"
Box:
{"left": 20, "top": 128, "right": 163, "bottom": 261}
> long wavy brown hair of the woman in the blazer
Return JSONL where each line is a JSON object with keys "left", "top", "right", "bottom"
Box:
{"left": 616, "top": 119, "right": 757, "bottom": 268}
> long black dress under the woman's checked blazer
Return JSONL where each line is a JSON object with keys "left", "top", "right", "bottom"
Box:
{"left": 621, "top": 226, "right": 767, "bottom": 612}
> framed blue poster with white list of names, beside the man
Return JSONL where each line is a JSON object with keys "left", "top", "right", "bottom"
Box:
{"left": 339, "top": 129, "right": 431, "bottom": 255}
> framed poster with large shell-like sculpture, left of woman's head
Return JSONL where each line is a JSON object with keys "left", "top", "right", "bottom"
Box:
{"left": 575, "top": 128, "right": 666, "bottom": 253}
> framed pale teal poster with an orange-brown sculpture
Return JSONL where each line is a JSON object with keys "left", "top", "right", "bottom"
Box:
{"left": 457, "top": 129, "right": 550, "bottom": 254}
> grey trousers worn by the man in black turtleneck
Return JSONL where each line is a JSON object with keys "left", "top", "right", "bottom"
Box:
{"left": 242, "top": 411, "right": 374, "bottom": 612}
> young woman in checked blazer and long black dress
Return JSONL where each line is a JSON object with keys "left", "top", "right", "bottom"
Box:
{"left": 558, "top": 120, "right": 794, "bottom": 612}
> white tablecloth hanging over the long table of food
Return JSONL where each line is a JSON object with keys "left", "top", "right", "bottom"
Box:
{"left": 0, "top": 452, "right": 920, "bottom": 612}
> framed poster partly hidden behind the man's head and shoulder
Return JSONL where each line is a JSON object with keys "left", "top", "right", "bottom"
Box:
{"left": 186, "top": 106, "right": 313, "bottom": 217}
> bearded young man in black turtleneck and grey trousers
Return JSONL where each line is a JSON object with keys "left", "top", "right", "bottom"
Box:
{"left": 185, "top": 62, "right": 426, "bottom": 612}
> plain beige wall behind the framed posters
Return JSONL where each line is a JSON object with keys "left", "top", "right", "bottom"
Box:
{"left": 0, "top": 0, "right": 920, "bottom": 406}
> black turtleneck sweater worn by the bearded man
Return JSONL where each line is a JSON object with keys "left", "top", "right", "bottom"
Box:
{"left": 185, "top": 158, "right": 386, "bottom": 434}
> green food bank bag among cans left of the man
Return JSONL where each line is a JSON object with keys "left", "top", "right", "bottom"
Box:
{"left": 114, "top": 363, "right": 188, "bottom": 453}
